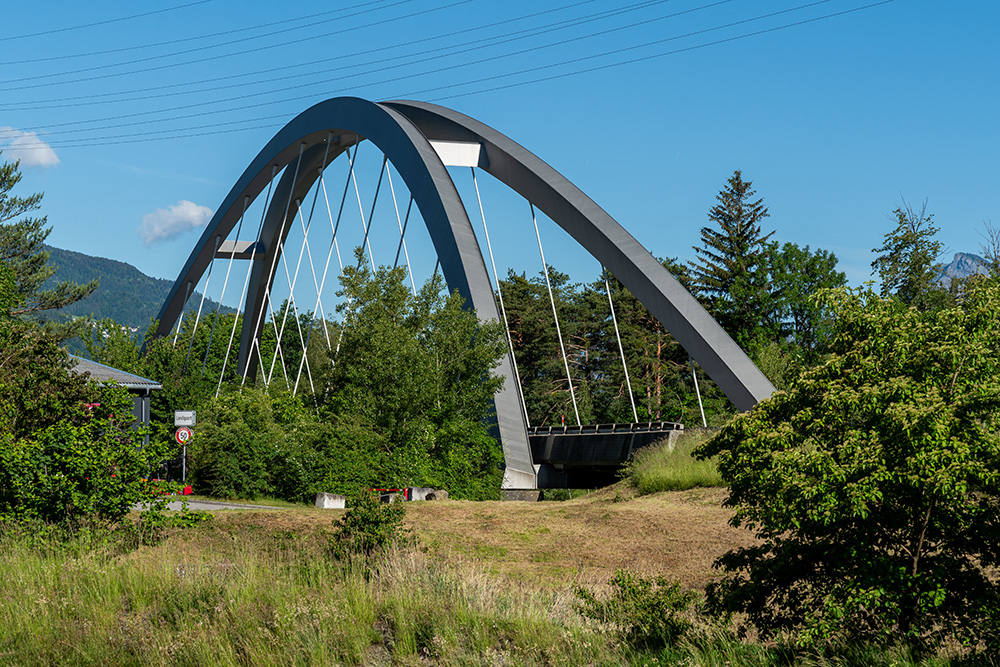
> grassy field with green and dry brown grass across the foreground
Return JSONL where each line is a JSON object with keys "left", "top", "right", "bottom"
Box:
{"left": 0, "top": 434, "right": 984, "bottom": 667}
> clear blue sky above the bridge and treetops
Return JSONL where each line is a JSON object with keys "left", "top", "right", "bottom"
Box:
{"left": 0, "top": 0, "right": 1000, "bottom": 306}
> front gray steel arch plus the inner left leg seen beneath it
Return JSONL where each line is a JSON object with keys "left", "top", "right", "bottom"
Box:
{"left": 156, "top": 97, "right": 535, "bottom": 488}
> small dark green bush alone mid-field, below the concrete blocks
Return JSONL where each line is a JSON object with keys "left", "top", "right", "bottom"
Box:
{"left": 330, "top": 489, "right": 409, "bottom": 559}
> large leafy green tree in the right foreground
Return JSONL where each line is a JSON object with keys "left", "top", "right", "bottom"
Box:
{"left": 700, "top": 281, "right": 1000, "bottom": 650}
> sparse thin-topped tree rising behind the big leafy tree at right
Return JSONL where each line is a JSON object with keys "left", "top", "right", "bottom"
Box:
{"left": 872, "top": 201, "right": 949, "bottom": 310}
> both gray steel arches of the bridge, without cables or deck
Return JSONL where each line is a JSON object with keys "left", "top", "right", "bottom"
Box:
{"left": 156, "top": 97, "right": 774, "bottom": 488}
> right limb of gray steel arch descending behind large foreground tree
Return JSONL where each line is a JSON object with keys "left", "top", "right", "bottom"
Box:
{"left": 383, "top": 101, "right": 774, "bottom": 410}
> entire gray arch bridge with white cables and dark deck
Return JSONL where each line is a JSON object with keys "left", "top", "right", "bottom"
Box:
{"left": 156, "top": 97, "right": 774, "bottom": 489}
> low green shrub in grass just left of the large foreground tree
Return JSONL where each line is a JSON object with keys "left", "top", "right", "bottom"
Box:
{"left": 576, "top": 570, "right": 698, "bottom": 649}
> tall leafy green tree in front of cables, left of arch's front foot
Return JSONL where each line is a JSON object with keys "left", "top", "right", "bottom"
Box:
{"left": 315, "top": 253, "right": 506, "bottom": 499}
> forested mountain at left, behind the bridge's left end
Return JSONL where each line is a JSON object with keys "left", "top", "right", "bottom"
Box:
{"left": 45, "top": 246, "right": 235, "bottom": 332}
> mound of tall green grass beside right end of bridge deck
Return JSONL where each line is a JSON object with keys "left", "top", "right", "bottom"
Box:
{"left": 622, "top": 429, "right": 723, "bottom": 495}
